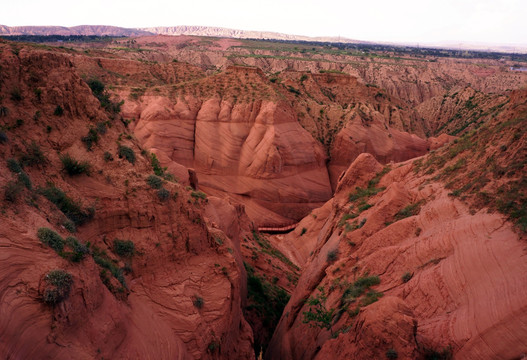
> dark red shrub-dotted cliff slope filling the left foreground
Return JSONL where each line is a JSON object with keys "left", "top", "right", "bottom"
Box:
{"left": 0, "top": 44, "right": 254, "bottom": 359}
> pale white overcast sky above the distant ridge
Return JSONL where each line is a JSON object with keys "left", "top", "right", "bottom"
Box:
{"left": 0, "top": 0, "right": 527, "bottom": 45}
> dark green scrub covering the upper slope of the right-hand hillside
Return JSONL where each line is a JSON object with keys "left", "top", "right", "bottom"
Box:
{"left": 420, "top": 103, "right": 527, "bottom": 232}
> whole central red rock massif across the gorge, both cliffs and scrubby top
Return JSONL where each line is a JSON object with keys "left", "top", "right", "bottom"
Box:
{"left": 119, "top": 67, "right": 438, "bottom": 224}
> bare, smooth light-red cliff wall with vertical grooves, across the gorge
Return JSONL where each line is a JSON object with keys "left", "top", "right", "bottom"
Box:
{"left": 129, "top": 68, "right": 331, "bottom": 224}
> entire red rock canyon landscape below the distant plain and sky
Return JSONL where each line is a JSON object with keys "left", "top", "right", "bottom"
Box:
{"left": 0, "top": 34, "right": 527, "bottom": 359}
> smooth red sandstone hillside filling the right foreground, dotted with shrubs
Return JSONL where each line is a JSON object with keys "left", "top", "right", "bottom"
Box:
{"left": 266, "top": 90, "right": 527, "bottom": 359}
